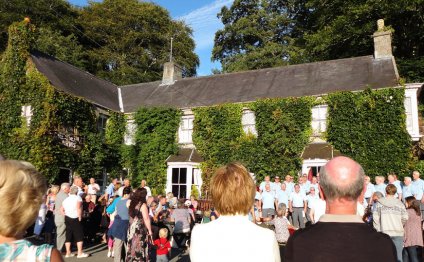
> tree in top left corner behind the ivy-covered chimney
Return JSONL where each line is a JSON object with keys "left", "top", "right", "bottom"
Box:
{"left": 0, "top": 0, "right": 84, "bottom": 68}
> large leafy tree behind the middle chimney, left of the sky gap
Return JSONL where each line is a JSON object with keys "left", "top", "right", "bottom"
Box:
{"left": 80, "top": 0, "right": 199, "bottom": 84}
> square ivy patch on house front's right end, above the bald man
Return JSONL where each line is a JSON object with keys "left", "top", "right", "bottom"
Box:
{"left": 327, "top": 89, "right": 412, "bottom": 177}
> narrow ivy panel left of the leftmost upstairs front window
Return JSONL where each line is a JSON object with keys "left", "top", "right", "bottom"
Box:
{"left": 132, "top": 108, "right": 181, "bottom": 194}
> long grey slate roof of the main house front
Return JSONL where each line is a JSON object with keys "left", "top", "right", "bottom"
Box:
{"left": 121, "top": 56, "right": 398, "bottom": 113}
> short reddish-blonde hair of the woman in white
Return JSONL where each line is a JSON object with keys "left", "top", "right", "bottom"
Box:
{"left": 210, "top": 163, "right": 256, "bottom": 215}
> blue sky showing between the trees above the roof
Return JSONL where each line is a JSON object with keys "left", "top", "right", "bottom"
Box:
{"left": 69, "top": 0, "right": 233, "bottom": 76}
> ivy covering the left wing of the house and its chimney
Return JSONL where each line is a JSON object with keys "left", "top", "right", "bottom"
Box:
{"left": 0, "top": 22, "right": 126, "bottom": 182}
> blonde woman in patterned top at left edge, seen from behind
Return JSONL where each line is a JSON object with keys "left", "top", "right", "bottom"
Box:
{"left": 0, "top": 160, "right": 63, "bottom": 262}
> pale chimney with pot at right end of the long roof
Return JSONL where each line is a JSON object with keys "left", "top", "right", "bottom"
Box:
{"left": 373, "top": 19, "right": 393, "bottom": 59}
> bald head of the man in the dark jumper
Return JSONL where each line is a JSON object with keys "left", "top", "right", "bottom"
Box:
{"left": 320, "top": 156, "right": 365, "bottom": 201}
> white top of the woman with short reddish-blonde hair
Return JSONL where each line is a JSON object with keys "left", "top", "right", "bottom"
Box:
{"left": 190, "top": 215, "right": 281, "bottom": 262}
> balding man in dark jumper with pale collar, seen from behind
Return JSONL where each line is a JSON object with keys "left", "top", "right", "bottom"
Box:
{"left": 284, "top": 157, "right": 396, "bottom": 262}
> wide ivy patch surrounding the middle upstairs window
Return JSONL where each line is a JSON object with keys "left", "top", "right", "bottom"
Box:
{"left": 193, "top": 98, "right": 312, "bottom": 192}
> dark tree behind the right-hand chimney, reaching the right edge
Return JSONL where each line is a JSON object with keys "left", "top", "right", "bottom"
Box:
{"left": 303, "top": 0, "right": 424, "bottom": 81}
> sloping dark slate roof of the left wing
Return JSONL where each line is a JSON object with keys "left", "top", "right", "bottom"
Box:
{"left": 31, "top": 51, "right": 120, "bottom": 111}
